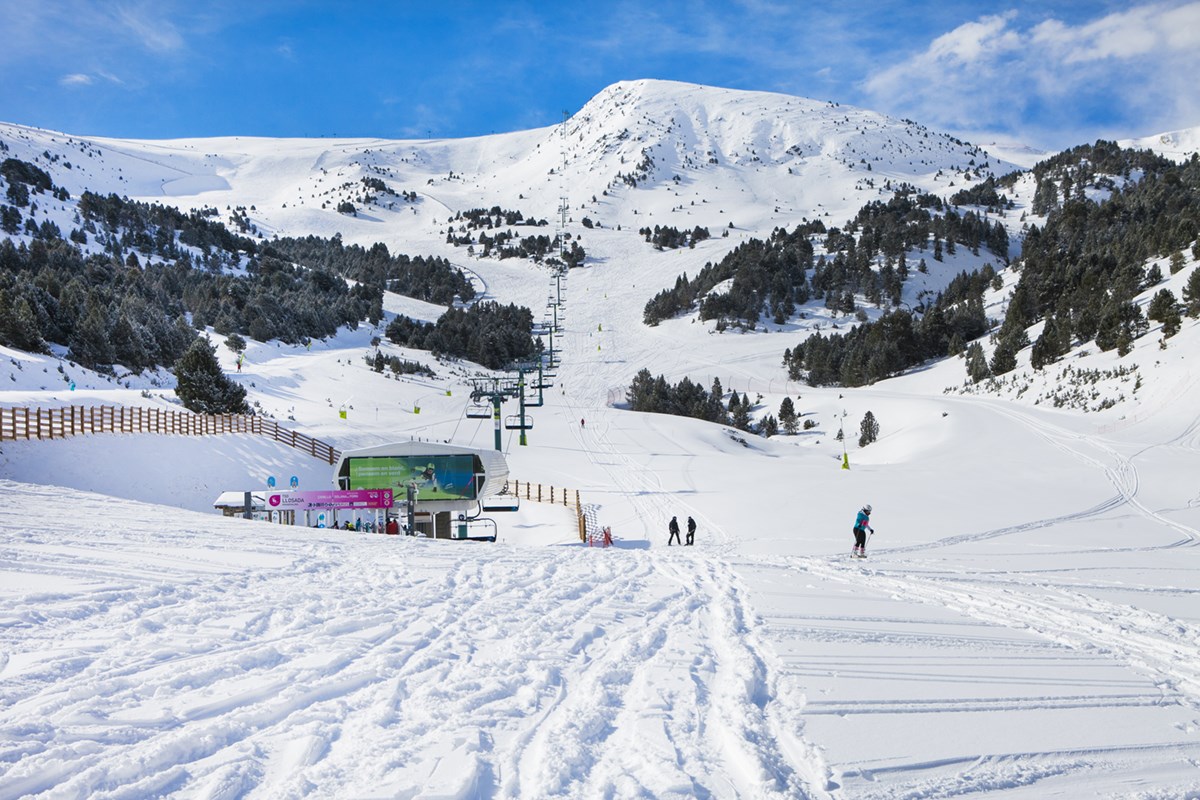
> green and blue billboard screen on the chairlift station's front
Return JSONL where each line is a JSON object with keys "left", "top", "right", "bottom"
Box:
{"left": 343, "top": 453, "right": 475, "bottom": 501}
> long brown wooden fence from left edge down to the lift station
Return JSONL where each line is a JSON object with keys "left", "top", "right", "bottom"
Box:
{"left": 0, "top": 405, "right": 341, "bottom": 464}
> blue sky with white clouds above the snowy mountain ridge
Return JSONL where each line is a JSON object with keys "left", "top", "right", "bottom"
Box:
{"left": 0, "top": 0, "right": 1200, "bottom": 149}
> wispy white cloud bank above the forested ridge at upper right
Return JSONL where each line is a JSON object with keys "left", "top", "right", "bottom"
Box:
{"left": 863, "top": 1, "right": 1200, "bottom": 146}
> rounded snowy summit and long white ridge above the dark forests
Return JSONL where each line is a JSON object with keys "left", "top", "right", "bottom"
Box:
{"left": 0, "top": 80, "right": 1016, "bottom": 248}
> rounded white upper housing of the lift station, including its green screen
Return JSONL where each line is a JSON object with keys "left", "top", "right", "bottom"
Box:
{"left": 332, "top": 441, "right": 509, "bottom": 507}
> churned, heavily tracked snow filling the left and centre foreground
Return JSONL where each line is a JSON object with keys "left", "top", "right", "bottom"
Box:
{"left": 0, "top": 503, "right": 828, "bottom": 799}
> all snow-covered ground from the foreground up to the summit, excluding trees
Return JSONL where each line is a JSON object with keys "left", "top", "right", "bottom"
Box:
{"left": 0, "top": 80, "right": 1200, "bottom": 800}
